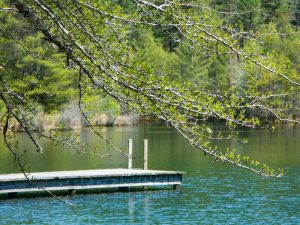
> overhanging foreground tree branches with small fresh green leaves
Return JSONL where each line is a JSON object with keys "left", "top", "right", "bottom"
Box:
{"left": 1, "top": 0, "right": 299, "bottom": 177}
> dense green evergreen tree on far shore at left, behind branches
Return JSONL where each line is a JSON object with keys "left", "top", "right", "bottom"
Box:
{"left": 0, "top": 6, "right": 76, "bottom": 111}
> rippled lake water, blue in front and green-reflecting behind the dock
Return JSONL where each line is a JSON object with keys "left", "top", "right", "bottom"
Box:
{"left": 0, "top": 125, "right": 300, "bottom": 224}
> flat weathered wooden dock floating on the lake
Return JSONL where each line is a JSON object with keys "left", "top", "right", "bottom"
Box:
{"left": 0, "top": 169, "right": 184, "bottom": 197}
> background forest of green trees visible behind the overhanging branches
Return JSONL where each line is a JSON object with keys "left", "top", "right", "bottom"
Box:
{"left": 0, "top": 0, "right": 300, "bottom": 125}
